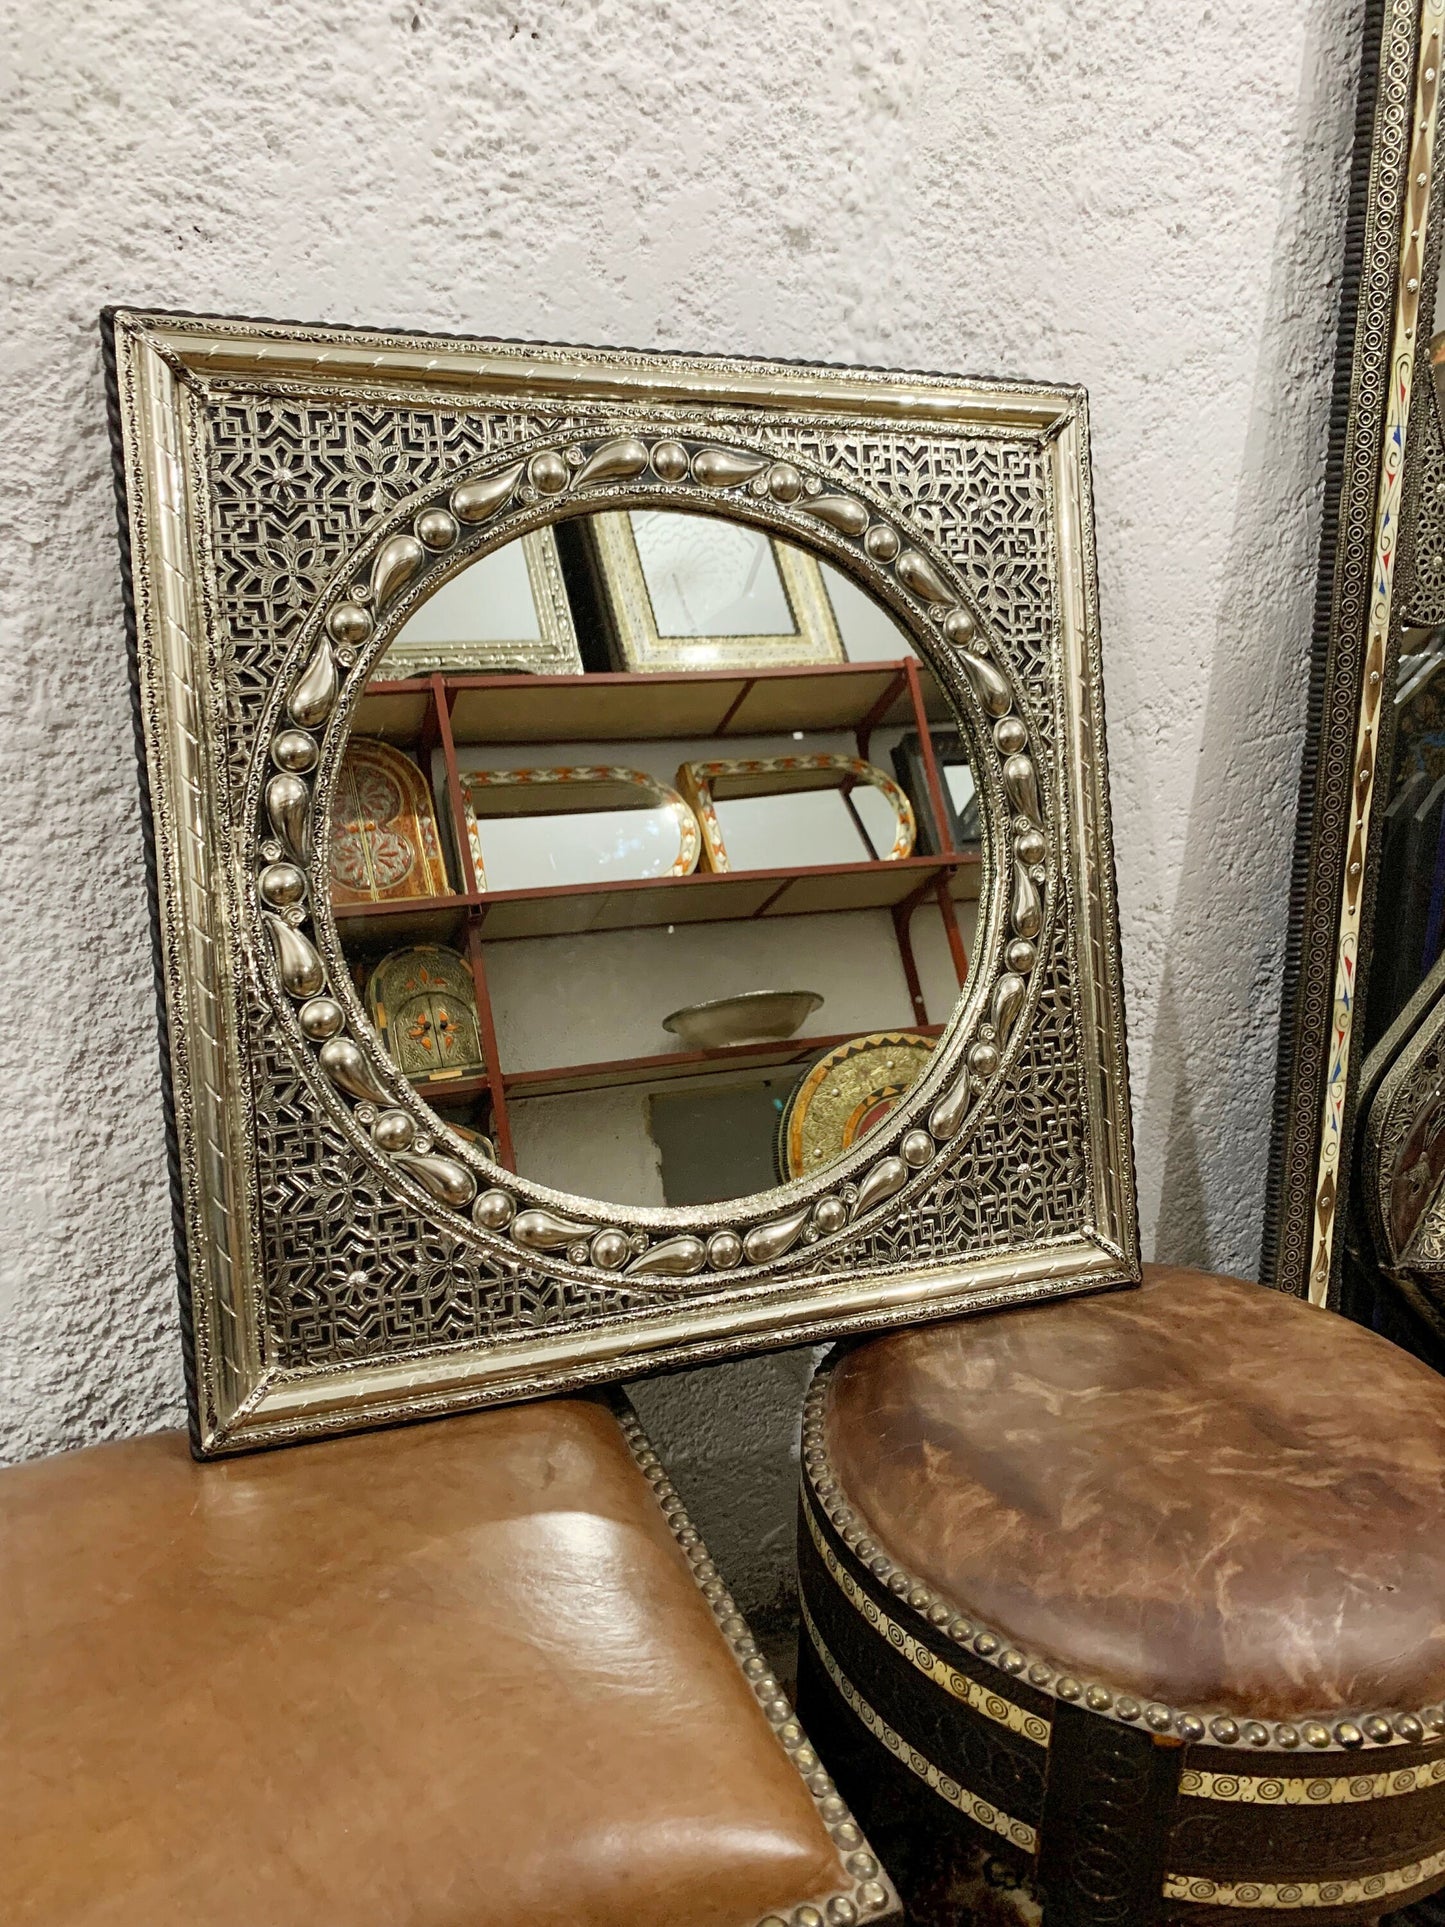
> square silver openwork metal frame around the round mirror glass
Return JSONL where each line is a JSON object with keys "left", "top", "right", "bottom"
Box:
{"left": 106, "top": 310, "right": 1139, "bottom": 1455}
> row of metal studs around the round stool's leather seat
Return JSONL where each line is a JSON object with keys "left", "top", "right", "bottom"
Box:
{"left": 803, "top": 1366, "right": 1445, "bottom": 1765}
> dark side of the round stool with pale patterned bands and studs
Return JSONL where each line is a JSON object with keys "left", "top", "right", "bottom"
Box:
{"left": 798, "top": 1310, "right": 1445, "bottom": 1927}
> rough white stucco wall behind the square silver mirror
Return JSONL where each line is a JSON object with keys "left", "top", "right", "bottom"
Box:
{"left": 0, "top": 0, "right": 1358, "bottom": 1610}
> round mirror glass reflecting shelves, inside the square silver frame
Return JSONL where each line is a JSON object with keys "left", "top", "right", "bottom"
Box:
{"left": 331, "top": 509, "right": 981, "bottom": 1206}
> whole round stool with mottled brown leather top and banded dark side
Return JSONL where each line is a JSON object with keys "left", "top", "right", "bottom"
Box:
{"left": 800, "top": 1266, "right": 1445, "bottom": 1927}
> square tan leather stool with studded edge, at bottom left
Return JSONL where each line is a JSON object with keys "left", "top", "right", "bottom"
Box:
{"left": 0, "top": 1399, "right": 894, "bottom": 1927}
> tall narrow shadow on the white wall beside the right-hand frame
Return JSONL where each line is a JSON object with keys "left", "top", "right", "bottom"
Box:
{"left": 1139, "top": 8, "right": 1358, "bottom": 1278}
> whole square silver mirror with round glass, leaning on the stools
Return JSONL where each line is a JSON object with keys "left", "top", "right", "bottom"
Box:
{"left": 106, "top": 310, "right": 1137, "bottom": 1453}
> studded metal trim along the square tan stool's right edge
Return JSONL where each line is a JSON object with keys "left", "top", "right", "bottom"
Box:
{"left": 611, "top": 1393, "right": 900, "bottom": 1927}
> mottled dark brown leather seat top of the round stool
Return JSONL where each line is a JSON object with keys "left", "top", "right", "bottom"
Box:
{"left": 825, "top": 1266, "right": 1445, "bottom": 1721}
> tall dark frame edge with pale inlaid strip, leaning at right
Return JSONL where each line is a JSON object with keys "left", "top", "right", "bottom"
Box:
{"left": 1262, "top": 0, "right": 1445, "bottom": 1305}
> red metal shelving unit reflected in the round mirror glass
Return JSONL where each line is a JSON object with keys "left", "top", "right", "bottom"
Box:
{"left": 337, "top": 657, "right": 979, "bottom": 1170}
